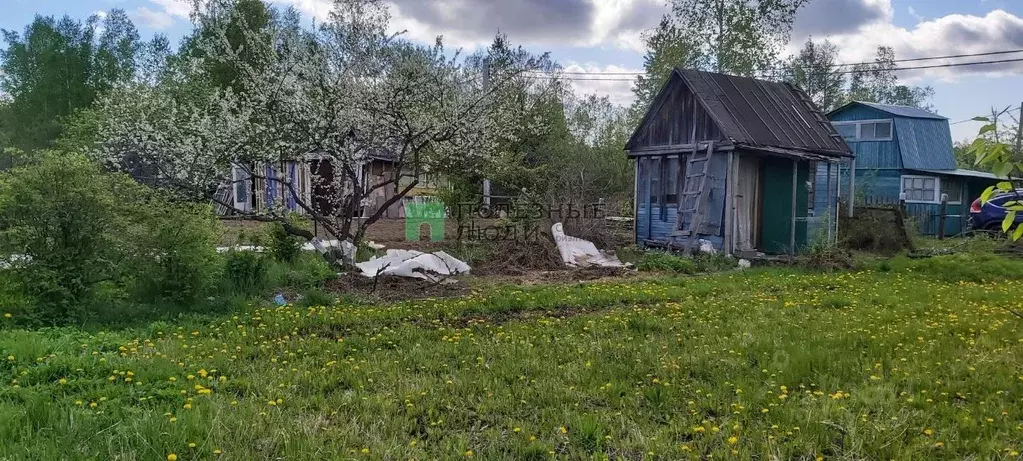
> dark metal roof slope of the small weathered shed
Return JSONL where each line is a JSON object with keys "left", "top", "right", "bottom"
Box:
{"left": 675, "top": 68, "right": 852, "bottom": 156}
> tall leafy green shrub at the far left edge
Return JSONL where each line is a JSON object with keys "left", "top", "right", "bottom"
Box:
{"left": 0, "top": 154, "right": 137, "bottom": 323}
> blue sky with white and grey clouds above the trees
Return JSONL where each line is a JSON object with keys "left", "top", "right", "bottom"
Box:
{"left": 0, "top": 0, "right": 1023, "bottom": 140}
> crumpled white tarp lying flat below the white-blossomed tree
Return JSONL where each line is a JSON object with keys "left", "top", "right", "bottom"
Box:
{"left": 355, "top": 249, "right": 470, "bottom": 282}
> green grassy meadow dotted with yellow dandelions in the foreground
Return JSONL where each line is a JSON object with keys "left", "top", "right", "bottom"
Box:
{"left": 0, "top": 257, "right": 1023, "bottom": 460}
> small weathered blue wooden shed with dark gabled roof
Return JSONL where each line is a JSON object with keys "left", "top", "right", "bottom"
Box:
{"left": 625, "top": 68, "right": 853, "bottom": 256}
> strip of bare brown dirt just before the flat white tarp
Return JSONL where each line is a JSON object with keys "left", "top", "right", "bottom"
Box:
{"left": 324, "top": 275, "right": 472, "bottom": 303}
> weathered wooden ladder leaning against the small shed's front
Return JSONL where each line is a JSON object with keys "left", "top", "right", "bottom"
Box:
{"left": 672, "top": 141, "right": 714, "bottom": 256}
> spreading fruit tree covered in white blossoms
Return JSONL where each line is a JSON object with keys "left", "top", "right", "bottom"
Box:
{"left": 96, "top": 0, "right": 534, "bottom": 249}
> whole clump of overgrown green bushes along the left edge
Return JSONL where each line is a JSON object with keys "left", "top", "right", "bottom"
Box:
{"left": 0, "top": 152, "right": 225, "bottom": 324}
